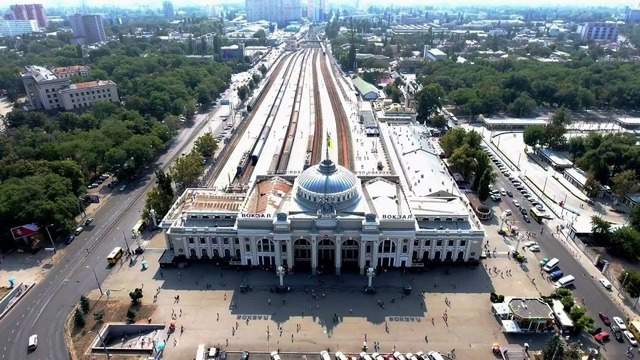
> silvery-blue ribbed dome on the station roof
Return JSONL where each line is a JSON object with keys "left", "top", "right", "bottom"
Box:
{"left": 296, "top": 159, "right": 360, "bottom": 209}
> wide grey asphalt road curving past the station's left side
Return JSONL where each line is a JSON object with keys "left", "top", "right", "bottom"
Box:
{"left": 0, "top": 105, "right": 222, "bottom": 360}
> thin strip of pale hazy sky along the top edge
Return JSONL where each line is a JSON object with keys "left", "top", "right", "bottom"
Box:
{"left": 12, "top": 0, "right": 640, "bottom": 8}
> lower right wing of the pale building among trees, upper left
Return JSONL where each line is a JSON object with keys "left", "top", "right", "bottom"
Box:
{"left": 59, "top": 80, "right": 120, "bottom": 110}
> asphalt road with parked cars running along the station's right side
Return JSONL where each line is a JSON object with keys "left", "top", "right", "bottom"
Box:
{"left": 488, "top": 143, "right": 637, "bottom": 359}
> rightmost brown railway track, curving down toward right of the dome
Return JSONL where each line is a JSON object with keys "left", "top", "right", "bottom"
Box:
{"left": 320, "top": 50, "right": 354, "bottom": 171}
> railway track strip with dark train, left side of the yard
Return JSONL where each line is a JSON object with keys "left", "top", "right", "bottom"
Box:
{"left": 231, "top": 52, "right": 302, "bottom": 188}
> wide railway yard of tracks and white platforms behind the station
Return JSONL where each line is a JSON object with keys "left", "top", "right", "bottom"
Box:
{"left": 203, "top": 40, "right": 372, "bottom": 192}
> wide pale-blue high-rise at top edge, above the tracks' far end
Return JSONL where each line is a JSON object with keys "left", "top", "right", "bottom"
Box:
{"left": 245, "top": 0, "right": 302, "bottom": 25}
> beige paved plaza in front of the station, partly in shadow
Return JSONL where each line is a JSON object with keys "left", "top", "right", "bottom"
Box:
{"left": 94, "top": 233, "right": 551, "bottom": 359}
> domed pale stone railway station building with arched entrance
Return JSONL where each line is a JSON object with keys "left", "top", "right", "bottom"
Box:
{"left": 161, "top": 156, "right": 484, "bottom": 274}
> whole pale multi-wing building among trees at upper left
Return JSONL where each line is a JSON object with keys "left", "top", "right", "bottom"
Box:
{"left": 21, "top": 65, "right": 119, "bottom": 110}
